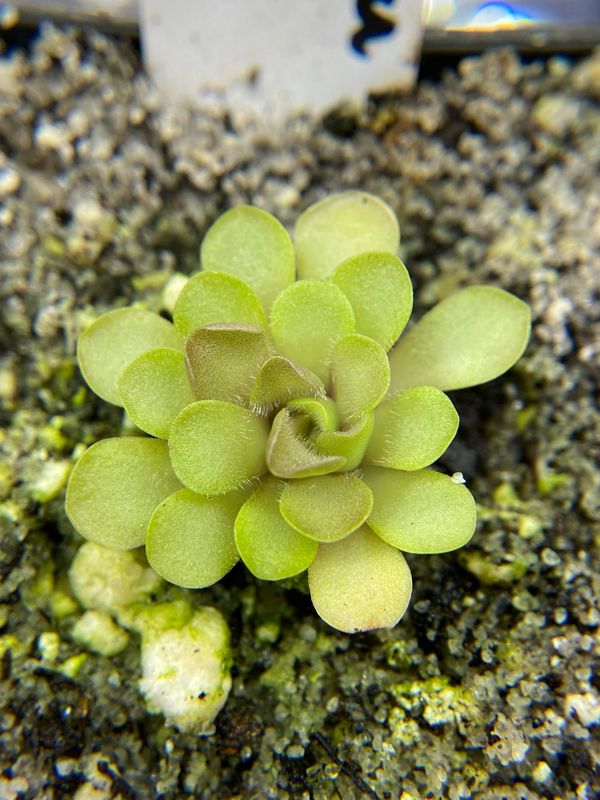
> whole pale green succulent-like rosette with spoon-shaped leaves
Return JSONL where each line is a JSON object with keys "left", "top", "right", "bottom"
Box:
{"left": 66, "top": 192, "right": 530, "bottom": 632}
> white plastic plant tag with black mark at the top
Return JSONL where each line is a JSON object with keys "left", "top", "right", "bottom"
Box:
{"left": 140, "top": 0, "right": 422, "bottom": 119}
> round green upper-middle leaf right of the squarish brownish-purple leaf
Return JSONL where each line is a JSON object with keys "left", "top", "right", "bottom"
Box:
{"left": 271, "top": 281, "right": 354, "bottom": 381}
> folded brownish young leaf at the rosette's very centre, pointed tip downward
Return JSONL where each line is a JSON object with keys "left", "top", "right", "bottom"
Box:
{"left": 267, "top": 408, "right": 345, "bottom": 478}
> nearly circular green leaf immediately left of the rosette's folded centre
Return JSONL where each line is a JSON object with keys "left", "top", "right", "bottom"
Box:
{"left": 169, "top": 400, "right": 267, "bottom": 495}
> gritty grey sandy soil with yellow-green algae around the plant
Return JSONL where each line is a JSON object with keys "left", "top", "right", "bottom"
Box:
{"left": 0, "top": 27, "right": 600, "bottom": 800}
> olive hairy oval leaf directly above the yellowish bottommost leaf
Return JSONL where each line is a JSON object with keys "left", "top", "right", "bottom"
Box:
{"left": 279, "top": 474, "right": 373, "bottom": 542}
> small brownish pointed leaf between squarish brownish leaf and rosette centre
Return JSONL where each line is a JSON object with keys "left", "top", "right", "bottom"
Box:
{"left": 249, "top": 356, "right": 325, "bottom": 414}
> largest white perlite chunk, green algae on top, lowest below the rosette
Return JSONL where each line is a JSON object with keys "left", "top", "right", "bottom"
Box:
{"left": 136, "top": 600, "right": 231, "bottom": 735}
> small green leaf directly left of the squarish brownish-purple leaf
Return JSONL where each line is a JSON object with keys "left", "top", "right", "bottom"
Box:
{"left": 119, "top": 347, "right": 195, "bottom": 439}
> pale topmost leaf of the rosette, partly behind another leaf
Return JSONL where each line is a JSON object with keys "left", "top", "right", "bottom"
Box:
{"left": 294, "top": 191, "right": 400, "bottom": 280}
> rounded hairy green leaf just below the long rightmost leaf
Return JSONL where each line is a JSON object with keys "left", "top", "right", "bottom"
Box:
{"left": 365, "top": 386, "right": 459, "bottom": 470}
